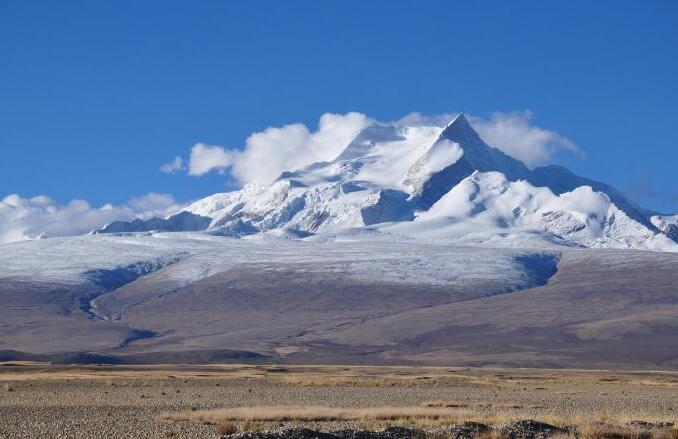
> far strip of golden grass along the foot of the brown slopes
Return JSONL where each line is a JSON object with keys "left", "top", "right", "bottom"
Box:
{"left": 0, "top": 362, "right": 678, "bottom": 389}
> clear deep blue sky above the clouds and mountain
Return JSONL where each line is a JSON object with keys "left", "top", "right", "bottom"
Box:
{"left": 0, "top": 0, "right": 678, "bottom": 212}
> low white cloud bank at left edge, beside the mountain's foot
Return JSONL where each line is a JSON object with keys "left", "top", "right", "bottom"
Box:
{"left": 0, "top": 193, "right": 182, "bottom": 243}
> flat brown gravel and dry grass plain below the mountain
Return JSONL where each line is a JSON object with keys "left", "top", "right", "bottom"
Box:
{"left": 0, "top": 362, "right": 678, "bottom": 438}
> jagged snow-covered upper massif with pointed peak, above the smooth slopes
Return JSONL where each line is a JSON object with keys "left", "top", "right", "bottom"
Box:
{"left": 95, "top": 114, "right": 678, "bottom": 251}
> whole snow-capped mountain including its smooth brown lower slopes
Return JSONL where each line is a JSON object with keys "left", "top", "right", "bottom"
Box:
{"left": 7, "top": 115, "right": 678, "bottom": 370}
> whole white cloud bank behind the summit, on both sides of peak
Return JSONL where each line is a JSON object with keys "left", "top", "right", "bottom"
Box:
{"left": 173, "top": 110, "right": 581, "bottom": 185}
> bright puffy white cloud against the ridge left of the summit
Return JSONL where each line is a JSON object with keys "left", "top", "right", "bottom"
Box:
{"left": 183, "top": 113, "right": 370, "bottom": 184}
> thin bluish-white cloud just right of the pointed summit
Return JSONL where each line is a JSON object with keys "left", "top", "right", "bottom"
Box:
{"left": 469, "top": 110, "right": 582, "bottom": 167}
